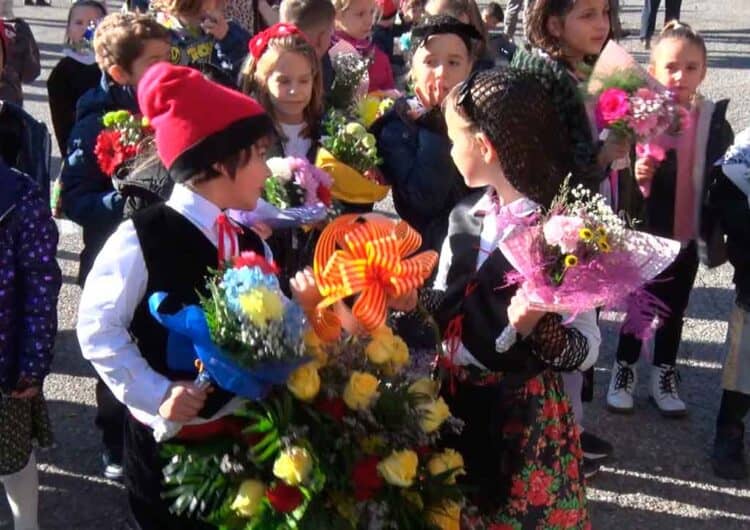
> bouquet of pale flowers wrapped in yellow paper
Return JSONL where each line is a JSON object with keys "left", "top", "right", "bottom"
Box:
{"left": 315, "top": 110, "right": 388, "bottom": 203}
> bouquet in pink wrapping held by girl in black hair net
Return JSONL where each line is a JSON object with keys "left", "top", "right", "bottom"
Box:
{"left": 500, "top": 175, "right": 680, "bottom": 338}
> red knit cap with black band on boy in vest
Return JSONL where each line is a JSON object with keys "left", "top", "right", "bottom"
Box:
{"left": 137, "top": 62, "right": 274, "bottom": 182}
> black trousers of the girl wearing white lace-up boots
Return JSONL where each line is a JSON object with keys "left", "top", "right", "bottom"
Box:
{"left": 617, "top": 241, "right": 698, "bottom": 366}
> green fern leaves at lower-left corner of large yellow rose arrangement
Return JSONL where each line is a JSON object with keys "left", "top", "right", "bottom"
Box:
{"left": 162, "top": 440, "right": 242, "bottom": 519}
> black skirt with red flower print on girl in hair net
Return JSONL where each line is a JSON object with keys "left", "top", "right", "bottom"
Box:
{"left": 445, "top": 370, "right": 590, "bottom": 530}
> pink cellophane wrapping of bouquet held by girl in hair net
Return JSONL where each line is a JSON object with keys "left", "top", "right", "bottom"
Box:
{"left": 500, "top": 225, "right": 680, "bottom": 339}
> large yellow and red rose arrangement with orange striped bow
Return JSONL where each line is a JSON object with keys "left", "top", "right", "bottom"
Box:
{"left": 163, "top": 216, "right": 464, "bottom": 530}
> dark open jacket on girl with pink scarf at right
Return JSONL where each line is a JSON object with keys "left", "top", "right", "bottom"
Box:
{"left": 643, "top": 100, "right": 734, "bottom": 267}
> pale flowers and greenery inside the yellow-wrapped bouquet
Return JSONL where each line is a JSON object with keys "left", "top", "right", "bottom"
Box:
{"left": 320, "top": 110, "right": 382, "bottom": 173}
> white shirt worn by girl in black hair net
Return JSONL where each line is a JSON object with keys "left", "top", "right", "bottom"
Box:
{"left": 434, "top": 193, "right": 602, "bottom": 370}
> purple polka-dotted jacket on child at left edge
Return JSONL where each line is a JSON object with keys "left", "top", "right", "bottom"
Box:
{"left": 0, "top": 162, "right": 61, "bottom": 392}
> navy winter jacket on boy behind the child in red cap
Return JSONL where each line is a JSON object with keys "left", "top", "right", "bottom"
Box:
{"left": 61, "top": 75, "right": 138, "bottom": 285}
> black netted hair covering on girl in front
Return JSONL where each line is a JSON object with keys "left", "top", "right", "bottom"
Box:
{"left": 455, "top": 68, "right": 573, "bottom": 207}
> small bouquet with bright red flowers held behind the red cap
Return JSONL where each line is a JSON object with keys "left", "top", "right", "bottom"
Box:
{"left": 94, "top": 110, "right": 153, "bottom": 177}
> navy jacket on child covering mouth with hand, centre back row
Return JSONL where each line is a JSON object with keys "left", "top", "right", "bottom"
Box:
{"left": 372, "top": 98, "right": 468, "bottom": 251}
